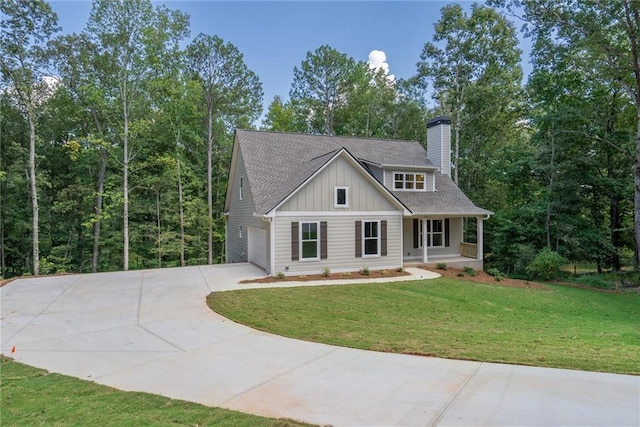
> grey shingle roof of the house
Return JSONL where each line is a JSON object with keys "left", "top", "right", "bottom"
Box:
{"left": 236, "top": 130, "right": 490, "bottom": 215}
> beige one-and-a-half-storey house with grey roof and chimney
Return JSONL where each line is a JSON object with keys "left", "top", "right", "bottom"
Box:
{"left": 225, "top": 117, "right": 492, "bottom": 275}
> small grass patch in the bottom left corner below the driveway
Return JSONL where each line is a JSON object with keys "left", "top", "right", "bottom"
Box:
{"left": 0, "top": 356, "right": 304, "bottom": 427}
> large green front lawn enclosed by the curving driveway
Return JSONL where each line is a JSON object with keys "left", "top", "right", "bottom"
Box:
{"left": 208, "top": 278, "right": 640, "bottom": 375}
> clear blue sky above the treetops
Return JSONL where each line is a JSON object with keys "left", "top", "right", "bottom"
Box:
{"left": 50, "top": 0, "right": 519, "bottom": 118}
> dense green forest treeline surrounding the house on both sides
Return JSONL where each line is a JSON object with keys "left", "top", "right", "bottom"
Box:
{"left": 0, "top": 0, "right": 640, "bottom": 277}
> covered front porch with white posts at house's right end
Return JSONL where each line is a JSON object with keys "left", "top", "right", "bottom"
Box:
{"left": 403, "top": 217, "right": 484, "bottom": 270}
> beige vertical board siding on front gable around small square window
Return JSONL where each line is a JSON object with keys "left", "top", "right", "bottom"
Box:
{"left": 278, "top": 157, "right": 398, "bottom": 212}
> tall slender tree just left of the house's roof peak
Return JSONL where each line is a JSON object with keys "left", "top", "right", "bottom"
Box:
{"left": 187, "top": 34, "right": 262, "bottom": 264}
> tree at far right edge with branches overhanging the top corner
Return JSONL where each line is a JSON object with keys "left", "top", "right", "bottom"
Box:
{"left": 495, "top": 0, "right": 640, "bottom": 268}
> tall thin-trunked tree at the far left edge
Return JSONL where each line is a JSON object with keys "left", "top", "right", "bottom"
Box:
{"left": 0, "top": 0, "right": 59, "bottom": 275}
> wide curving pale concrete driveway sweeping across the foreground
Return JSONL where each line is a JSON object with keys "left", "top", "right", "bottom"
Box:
{"left": 0, "top": 264, "right": 640, "bottom": 426}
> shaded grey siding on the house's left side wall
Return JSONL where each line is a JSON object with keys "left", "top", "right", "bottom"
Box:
{"left": 226, "top": 147, "right": 271, "bottom": 271}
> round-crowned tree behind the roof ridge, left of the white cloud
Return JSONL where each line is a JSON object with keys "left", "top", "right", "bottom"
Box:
{"left": 289, "top": 45, "right": 356, "bottom": 135}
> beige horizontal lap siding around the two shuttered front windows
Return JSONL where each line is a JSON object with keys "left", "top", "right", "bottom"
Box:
{"left": 272, "top": 211, "right": 402, "bottom": 275}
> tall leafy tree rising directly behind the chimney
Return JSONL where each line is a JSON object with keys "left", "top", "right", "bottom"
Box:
{"left": 417, "top": 4, "right": 522, "bottom": 184}
